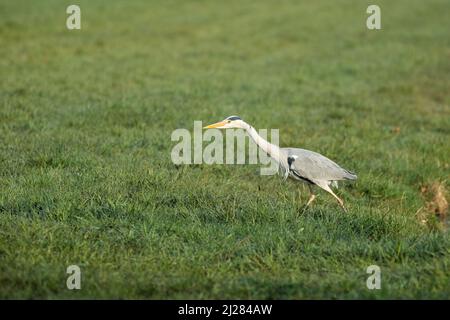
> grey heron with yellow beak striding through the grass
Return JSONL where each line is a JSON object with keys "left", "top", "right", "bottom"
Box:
{"left": 204, "top": 116, "right": 357, "bottom": 211}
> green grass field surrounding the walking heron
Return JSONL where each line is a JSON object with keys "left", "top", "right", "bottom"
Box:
{"left": 0, "top": 0, "right": 450, "bottom": 299}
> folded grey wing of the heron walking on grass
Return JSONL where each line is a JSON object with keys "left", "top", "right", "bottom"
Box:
{"left": 283, "top": 148, "right": 357, "bottom": 182}
